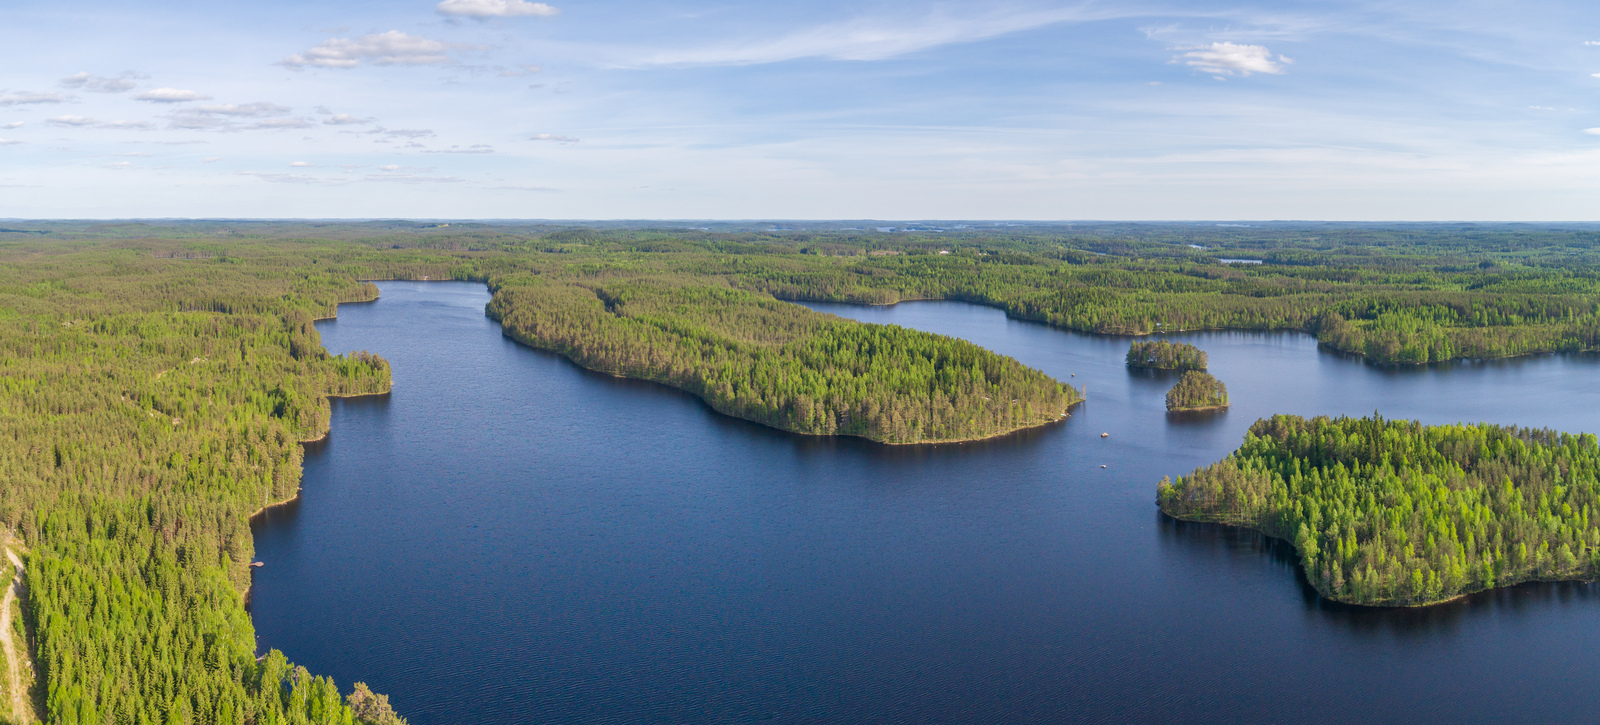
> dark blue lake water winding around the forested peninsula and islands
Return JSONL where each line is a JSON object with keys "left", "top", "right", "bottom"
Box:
{"left": 253, "top": 282, "right": 1600, "bottom": 725}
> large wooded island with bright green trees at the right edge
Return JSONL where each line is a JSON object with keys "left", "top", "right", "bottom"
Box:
{"left": 1155, "top": 416, "right": 1600, "bottom": 607}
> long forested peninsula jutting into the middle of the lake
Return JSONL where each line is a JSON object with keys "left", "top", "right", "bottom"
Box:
{"left": 490, "top": 278, "right": 1080, "bottom": 443}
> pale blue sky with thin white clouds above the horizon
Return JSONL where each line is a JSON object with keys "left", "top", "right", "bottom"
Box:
{"left": 0, "top": 0, "right": 1600, "bottom": 221}
